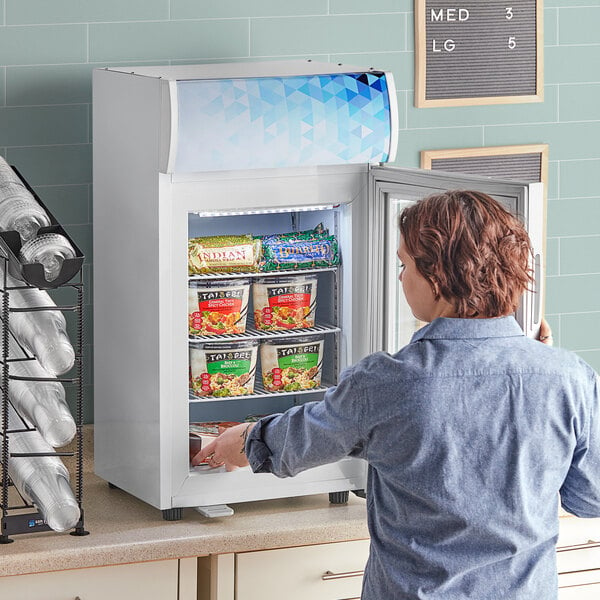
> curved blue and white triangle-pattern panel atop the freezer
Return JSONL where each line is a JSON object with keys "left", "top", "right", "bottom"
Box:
{"left": 175, "top": 72, "right": 391, "bottom": 171}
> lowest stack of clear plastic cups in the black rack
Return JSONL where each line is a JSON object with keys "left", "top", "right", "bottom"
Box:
{"left": 8, "top": 407, "right": 81, "bottom": 531}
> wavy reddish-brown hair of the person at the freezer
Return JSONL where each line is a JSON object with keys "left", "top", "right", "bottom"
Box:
{"left": 399, "top": 190, "right": 531, "bottom": 318}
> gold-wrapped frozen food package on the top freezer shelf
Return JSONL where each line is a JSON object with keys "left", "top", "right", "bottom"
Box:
{"left": 188, "top": 235, "right": 261, "bottom": 275}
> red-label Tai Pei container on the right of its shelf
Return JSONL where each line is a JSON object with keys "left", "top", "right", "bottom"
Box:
{"left": 252, "top": 275, "right": 318, "bottom": 331}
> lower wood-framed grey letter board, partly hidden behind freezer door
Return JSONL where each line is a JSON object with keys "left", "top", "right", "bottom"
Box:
{"left": 421, "top": 144, "right": 548, "bottom": 197}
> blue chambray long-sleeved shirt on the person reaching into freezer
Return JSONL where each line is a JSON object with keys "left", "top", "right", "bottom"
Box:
{"left": 246, "top": 317, "right": 600, "bottom": 600}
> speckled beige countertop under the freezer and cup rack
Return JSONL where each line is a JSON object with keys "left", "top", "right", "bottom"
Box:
{"left": 0, "top": 428, "right": 368, "bottom": 576}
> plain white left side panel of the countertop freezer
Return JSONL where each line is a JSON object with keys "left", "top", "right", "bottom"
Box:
{"left": 93, "top": 70, "right": 169, "bottom": 506}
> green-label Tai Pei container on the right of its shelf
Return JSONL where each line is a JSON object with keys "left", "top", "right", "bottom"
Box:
{"left": 260, "top": 336, "right": 324, "bottom": 392}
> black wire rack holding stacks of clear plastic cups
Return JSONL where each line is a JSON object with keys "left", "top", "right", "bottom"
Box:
{"left": 0, "top": 167, "right": 89, "bottom": 544}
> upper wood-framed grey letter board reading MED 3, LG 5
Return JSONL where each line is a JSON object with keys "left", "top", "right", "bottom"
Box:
{"left": 415, "top": 0, "right": 544, "bottom": 108}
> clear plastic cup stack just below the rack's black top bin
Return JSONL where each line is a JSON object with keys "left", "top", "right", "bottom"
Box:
{"left": 0, "top": 269, "right": 75, "bottom": 375}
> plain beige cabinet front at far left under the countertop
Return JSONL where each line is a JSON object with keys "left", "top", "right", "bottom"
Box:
{"left": 0, "top": 560, "right": 178, "bottom": 600}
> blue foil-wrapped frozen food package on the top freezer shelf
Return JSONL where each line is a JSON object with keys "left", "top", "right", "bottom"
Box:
{"left": 260, "top": 225, "right": 340, "bottom": 271}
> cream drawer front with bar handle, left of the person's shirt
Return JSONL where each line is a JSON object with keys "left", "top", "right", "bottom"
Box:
{"left": 236, "top": 540, "right": 369, "bottom": 600}
